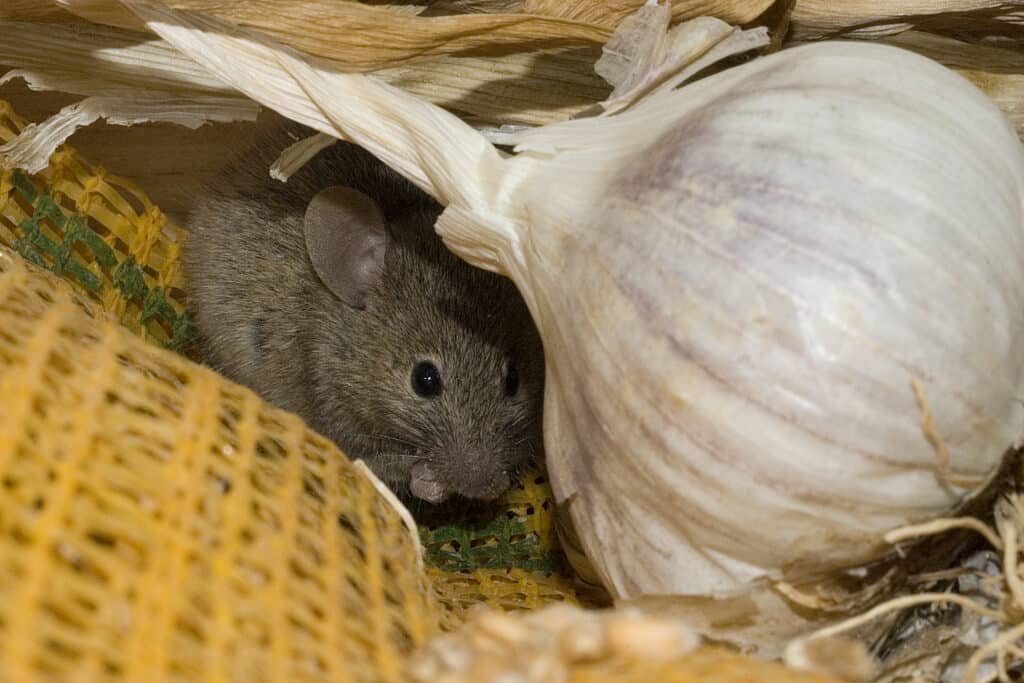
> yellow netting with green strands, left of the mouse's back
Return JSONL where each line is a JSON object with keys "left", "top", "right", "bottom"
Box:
{"left": 0, "top": 100, "right": 193, "bottom": 349}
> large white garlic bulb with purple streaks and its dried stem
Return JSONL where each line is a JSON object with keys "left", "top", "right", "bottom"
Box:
{"left": 22, "top": 0, "right": 1024, "bottom": 622}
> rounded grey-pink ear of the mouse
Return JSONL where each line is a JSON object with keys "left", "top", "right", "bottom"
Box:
{"left": 303, "top": 185, "right": 388, "bottom": 308}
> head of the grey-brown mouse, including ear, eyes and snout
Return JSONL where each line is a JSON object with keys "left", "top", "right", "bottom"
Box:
{"left": 304, "top": 186, "right": 544, "bottom": 503}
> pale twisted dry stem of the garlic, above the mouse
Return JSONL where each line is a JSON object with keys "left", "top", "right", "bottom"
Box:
{"left": 101, "top": 0, "right": 502, "bottom": 223}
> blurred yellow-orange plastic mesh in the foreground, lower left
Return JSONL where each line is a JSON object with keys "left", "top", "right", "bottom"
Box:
{"left": 0, "top": 250, "right": 439, "bottom": 681}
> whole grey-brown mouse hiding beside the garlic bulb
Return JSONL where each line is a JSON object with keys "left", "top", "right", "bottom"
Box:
{"left": 184, "top": 122, "right": 544, "bottom": 503}
